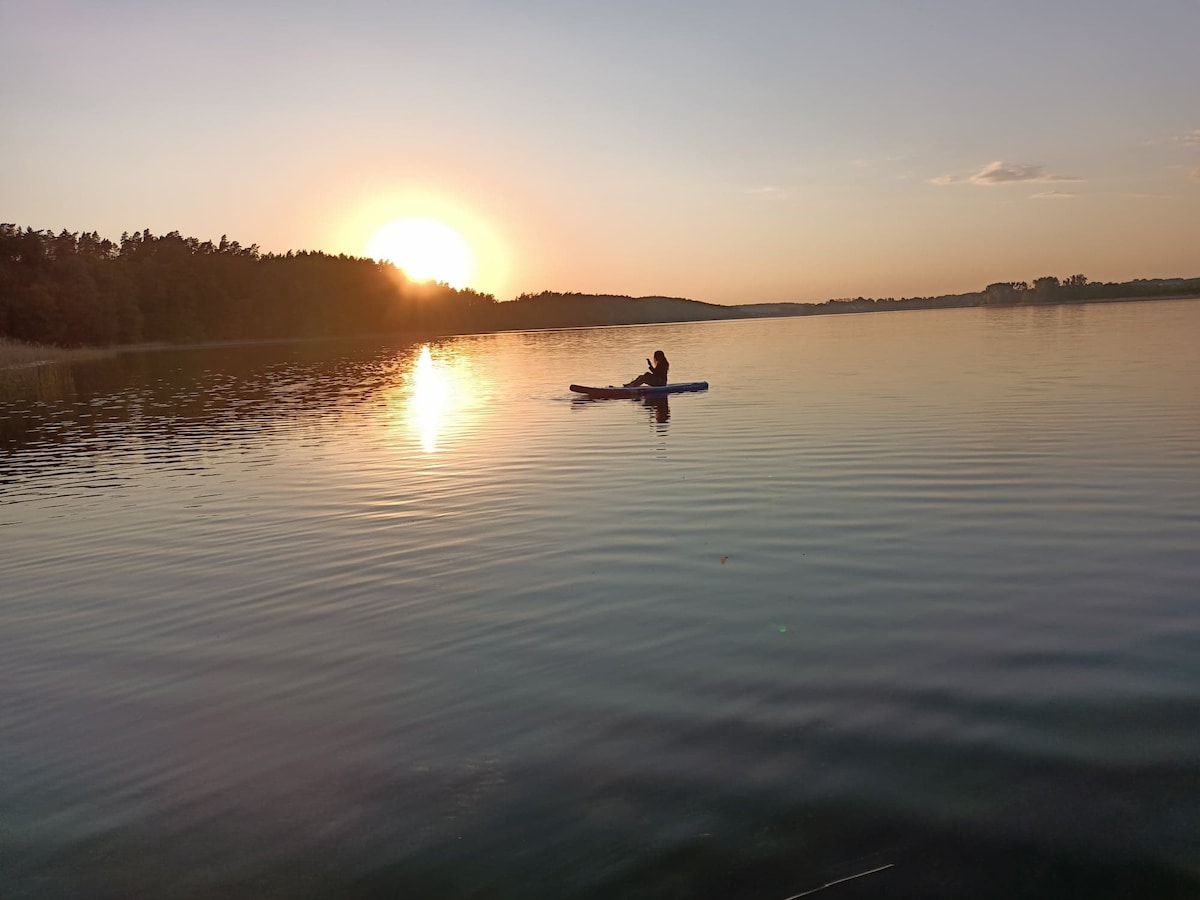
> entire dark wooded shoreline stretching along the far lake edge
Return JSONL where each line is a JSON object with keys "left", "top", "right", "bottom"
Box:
{"left": 0, "top": 224, "right": 1200, "bottom": 347}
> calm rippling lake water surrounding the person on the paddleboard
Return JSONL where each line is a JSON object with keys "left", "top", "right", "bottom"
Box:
{"left": 0, "top": 301, "right": 1200, "bottom": 900}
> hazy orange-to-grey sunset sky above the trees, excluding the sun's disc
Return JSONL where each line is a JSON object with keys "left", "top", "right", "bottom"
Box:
{"left": 0, "top": 0, "right": 1200, "bottom": 304}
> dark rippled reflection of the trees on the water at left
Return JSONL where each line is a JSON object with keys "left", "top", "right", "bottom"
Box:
{"left": 0, "top": 342, "right": 424, "bottom": 460}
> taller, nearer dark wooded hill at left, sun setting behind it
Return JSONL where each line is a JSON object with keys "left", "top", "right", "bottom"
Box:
{"left": 0, "top": 224, "right": 496, "bottom": 347}
